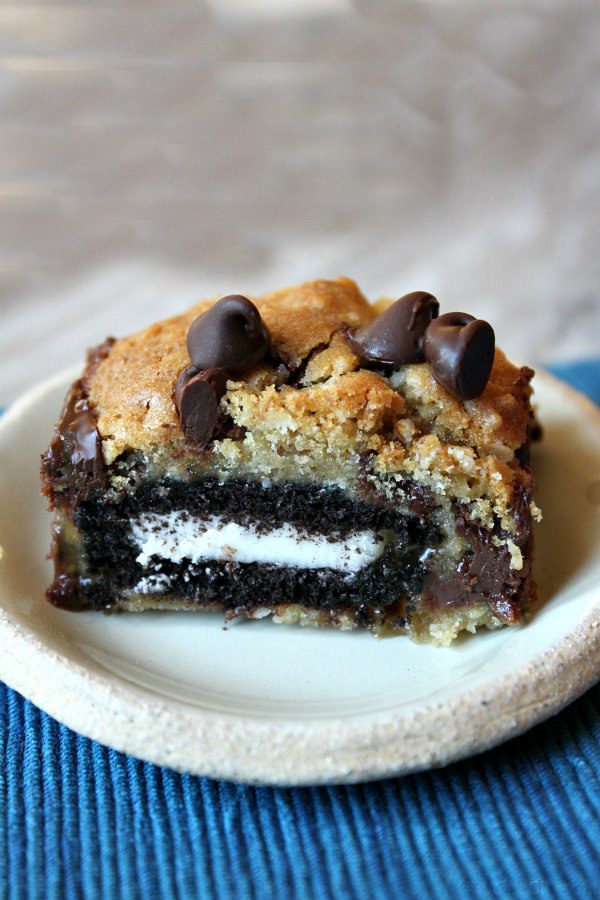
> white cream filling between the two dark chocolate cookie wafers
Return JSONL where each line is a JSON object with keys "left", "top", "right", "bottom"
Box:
{"left": 131, "top": 511, "right": 386, "bottom": 573}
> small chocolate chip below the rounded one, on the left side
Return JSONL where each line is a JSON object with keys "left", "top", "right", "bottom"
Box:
{"left": 175, "top": 366, "right": 227, "bottom": 449}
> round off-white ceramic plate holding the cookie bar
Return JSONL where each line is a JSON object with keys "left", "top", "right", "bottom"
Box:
{"left": 0, "top": 372, "right": 600, "bottom": 784}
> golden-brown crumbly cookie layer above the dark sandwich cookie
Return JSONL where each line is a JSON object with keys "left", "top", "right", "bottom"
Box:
{"left": 86, "top": 278, "right": 533, "bottom": 520}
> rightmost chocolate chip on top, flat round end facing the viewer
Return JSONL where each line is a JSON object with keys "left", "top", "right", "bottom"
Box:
{"left": 423, "top": 312, "right": 494, "bottom": 400}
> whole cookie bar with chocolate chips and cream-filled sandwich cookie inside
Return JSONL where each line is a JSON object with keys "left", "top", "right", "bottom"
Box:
{"left": 42, "top": 278, "right": 539, "bottom": 645}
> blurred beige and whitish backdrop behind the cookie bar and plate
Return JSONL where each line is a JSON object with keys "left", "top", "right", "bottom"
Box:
{"left": 0, "top": 0, "right": 600, "bottom": 402}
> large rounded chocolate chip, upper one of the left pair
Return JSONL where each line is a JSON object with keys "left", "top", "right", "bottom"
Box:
{"left": 187, "top": 294, "right": 271, "bottom": 375}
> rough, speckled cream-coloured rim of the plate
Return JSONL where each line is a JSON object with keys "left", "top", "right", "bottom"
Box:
{"left": 0, "top": 367, "right": 600, "bottom": 786}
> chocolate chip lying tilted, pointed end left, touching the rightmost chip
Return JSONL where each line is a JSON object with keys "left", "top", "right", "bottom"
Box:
{"left": 348, "top": 291, "right": 440, "bottom": 366}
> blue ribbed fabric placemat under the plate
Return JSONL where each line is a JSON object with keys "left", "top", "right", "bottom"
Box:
{"left": 0, "top": 360, "right": 600, "bottom": 900}
